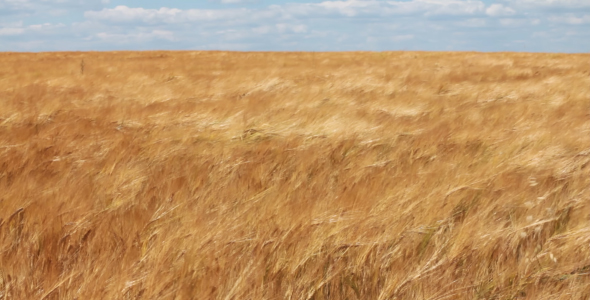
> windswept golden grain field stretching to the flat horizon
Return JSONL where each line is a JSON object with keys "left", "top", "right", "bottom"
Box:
{"left": 0, "top": 52, "right": 590, "bottom": 300}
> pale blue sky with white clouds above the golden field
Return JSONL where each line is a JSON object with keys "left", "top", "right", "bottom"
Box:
{"left": 0, "top": 0, "right": 590, "bottom": 53}
